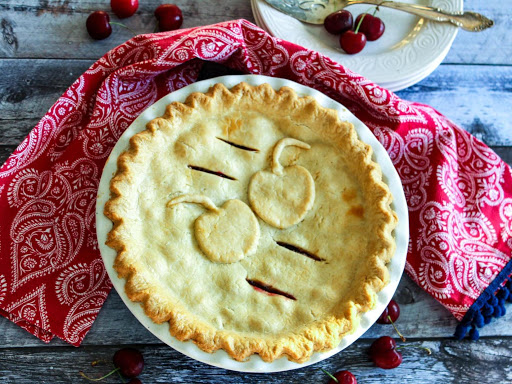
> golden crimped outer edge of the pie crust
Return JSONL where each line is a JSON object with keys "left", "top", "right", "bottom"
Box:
{"left": 104, "top": 83, "right": 397, "bottom": 363}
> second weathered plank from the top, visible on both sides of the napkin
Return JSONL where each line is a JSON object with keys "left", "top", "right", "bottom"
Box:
{"left": 0, "top": 59, "right": 512, "bottom": 146}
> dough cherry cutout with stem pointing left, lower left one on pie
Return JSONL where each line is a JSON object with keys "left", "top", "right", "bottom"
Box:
{"left": 167, "top": 195, "right": 260, "bottom": 263}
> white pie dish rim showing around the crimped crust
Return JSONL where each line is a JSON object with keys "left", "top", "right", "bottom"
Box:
{"left": 96, "top": 75, "right": 409, "bottom": 372}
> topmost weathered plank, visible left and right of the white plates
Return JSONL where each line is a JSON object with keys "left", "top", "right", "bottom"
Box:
{"left": 0, "top": 0, "right": 506, "bottom": 64}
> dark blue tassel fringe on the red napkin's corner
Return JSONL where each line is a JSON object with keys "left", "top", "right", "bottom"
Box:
{"left": 454, "top": 260, "right": 512, "bottom": 340}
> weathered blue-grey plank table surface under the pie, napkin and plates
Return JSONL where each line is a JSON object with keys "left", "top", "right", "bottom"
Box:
{"left": 0, "top": 0, "right": 512, "bottom": 384}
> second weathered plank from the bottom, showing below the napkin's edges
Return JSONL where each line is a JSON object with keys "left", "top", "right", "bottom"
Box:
{"left": 0, "top": 277, "right": 512, "bottom": 348}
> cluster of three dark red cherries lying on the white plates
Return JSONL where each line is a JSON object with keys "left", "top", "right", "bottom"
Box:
{"left": 324, "top": 10, "right": 385, "bottom": 54}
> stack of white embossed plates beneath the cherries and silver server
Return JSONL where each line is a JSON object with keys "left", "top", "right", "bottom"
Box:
{"left": 251, "top": 0, "right": 463, "bottom": 91}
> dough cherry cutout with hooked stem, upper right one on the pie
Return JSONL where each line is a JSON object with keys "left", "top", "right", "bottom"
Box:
{"left": 248, "top": 138, "right": 315, "bottom": 229}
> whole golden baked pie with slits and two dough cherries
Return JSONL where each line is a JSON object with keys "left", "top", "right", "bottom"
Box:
{"left": 104, "top": 83, "right": 397, "bottom": 363}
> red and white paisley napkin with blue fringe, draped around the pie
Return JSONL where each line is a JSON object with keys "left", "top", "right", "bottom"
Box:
{"left": 0, "top": 20, "right": 512, "bottom": 346}
